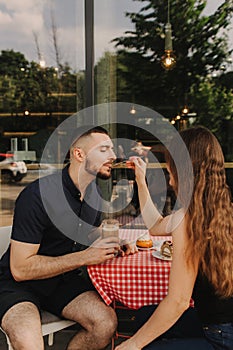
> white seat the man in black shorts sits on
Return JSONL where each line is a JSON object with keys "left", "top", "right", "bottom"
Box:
{"left": 0, "top": 226, "right": 75, "bottom": 350}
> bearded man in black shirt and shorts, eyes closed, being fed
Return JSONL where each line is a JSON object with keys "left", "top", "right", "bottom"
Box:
{"left": 0, "top": 127, "right": 119, "bottom": 350}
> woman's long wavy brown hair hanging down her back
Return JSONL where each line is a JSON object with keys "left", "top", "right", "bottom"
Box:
{"left": 166, "top": 126, "right": 233, "bottom": 297}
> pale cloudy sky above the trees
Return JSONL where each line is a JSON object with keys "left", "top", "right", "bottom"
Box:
{"left": 0, "top": 0, "right": 233, "bottom": 71}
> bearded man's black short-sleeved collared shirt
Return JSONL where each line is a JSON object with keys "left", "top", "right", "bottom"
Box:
{"left": 0, "top": 166, "right": 101, "bottom": 274}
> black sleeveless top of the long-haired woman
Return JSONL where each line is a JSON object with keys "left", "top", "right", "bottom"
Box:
{"left": 192, "top": 273, "right": 233, "bottom": 325}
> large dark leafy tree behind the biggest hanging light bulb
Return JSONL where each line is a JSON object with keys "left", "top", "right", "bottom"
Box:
{"left": 114, "top": 0, "right": 233, "bottom": 117}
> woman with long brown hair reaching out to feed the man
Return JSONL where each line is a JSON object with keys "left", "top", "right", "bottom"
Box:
{"left": 116, "top": 127, "right": 233, "bottom": 350}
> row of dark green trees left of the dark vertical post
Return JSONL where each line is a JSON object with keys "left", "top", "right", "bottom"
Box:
{"left": 0, "top": 50, "right": 77, "bottom": 114}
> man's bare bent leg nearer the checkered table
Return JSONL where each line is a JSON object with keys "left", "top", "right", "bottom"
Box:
{"left": 62, "top": 291, "right": 117, "bottom": 350}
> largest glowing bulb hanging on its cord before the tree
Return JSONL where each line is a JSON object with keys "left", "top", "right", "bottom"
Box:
{"left": 161, "top": 0, "right": 176, "bottom": 70}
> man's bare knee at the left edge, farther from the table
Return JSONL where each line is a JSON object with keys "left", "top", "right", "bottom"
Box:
{"left": 1, "top": 302, "right": 44, "bottom": 350}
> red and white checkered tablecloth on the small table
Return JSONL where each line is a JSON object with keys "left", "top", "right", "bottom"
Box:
{"left": 88, "top": 229, "right": 171, "bottom": 309}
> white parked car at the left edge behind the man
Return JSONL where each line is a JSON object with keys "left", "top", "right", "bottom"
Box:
{"left": 0, "top": 153, "right": 27, "bottom": 182}
